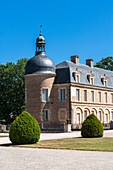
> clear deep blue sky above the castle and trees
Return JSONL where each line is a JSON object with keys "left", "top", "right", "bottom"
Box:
{"left": 0, "top": 0, "right": 113, "bottom": 64}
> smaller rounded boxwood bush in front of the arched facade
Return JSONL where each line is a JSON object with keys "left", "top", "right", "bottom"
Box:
{"left": 81, "top": 114, "right": 103, "bottom": 138}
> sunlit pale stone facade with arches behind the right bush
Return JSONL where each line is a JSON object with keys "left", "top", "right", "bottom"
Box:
{"left": 71, "top": 85, "right": 113, "bottom": 128}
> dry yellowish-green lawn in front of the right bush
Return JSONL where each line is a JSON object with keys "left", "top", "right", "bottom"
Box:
{"left": 21, "top": 138, "right": 113, "bottom": 152}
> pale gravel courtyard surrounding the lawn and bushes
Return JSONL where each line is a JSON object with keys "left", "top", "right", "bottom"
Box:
{"left": 0, "top": 130, "right": 113, "bottom": 170}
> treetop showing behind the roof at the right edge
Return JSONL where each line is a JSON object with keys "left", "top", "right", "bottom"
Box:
{"left": 95, "top": 56, "right": 113, "bottom": 71}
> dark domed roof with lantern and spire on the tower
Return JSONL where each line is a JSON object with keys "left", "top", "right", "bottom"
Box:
{"left": 25, "top": 26, "right": 55, "bottom": 75}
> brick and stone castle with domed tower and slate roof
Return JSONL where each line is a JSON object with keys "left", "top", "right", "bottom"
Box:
{"left": 25, "top": 28, "right": 113, "bottom": 131}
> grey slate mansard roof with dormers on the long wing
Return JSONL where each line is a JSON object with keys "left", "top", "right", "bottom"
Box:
{"left": 54, "top": 61, "right": 113, "bottom": 88}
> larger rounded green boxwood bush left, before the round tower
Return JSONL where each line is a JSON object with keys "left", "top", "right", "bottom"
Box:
{"left": 9, "top": 111, "right": 40, "bottom": 145}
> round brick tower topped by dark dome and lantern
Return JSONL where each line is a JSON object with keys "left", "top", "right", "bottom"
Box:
{"left": 25, "top": 26, "right": 56, "bottom": 124}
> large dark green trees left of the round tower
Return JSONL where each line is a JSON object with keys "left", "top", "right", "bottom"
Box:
{"left": 0, "top": 58, "right": 27, "bottom": 121}
